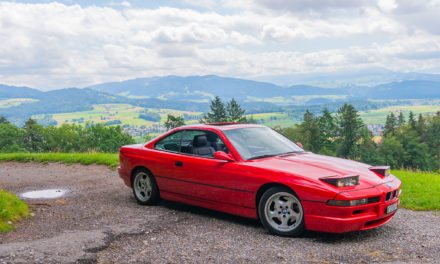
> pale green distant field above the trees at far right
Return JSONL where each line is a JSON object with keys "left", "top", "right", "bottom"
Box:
{"left": 359, "top": 105, "right": 440, "bottom": 124}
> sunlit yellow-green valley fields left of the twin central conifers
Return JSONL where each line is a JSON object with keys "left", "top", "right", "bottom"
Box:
{"left": 32, "top": 104, "right": 201, "bottom": 127}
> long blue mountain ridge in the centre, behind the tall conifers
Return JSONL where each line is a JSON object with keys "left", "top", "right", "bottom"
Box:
{"left": 87, "top": 75, "right": 346, "bottom": 100}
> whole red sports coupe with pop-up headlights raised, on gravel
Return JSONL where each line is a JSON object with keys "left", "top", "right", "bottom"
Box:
{"left": 118, "top": 123, "right": 401, "bottom": 236}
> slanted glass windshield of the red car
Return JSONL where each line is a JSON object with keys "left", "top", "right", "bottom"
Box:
{"left": 224, "top": 127, "right": 304, "bottom": 160}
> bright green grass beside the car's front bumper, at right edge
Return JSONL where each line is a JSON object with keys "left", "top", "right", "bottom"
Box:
{"left": 392, "top": 170, "right": 440, "bottom": 210}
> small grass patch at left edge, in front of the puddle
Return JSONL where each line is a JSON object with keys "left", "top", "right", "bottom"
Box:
{"left": 0, "top": 190, "right": 29, "bottom": 232}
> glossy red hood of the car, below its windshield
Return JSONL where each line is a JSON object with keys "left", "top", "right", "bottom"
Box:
{"left": 249, "top": 152, "right": 394, "bottom": 189}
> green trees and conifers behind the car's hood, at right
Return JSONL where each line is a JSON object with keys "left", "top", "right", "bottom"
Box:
{"left": 278, "top": 104, "right": 440, "bottom": 171}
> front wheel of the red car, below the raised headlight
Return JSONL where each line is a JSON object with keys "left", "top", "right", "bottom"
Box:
{"left": 258, "top": 186, "right": 305, "bottom": 236}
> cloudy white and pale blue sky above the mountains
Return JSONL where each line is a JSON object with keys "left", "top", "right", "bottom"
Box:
{"left": 0, "top": 0, "right": 440, "bottom": 90}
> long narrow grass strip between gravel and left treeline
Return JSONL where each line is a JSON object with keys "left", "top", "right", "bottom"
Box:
{"left": 0, "top": 153, "right": 119, "bottom": 169}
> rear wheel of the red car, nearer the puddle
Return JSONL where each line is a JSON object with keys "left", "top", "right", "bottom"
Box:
{"left": 132, "top": 169, "right": 160, "bottom": 205}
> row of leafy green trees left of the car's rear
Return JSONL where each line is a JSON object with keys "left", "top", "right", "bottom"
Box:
{"left": 0, "top": 117, "right": 135, "bottom": 153}
